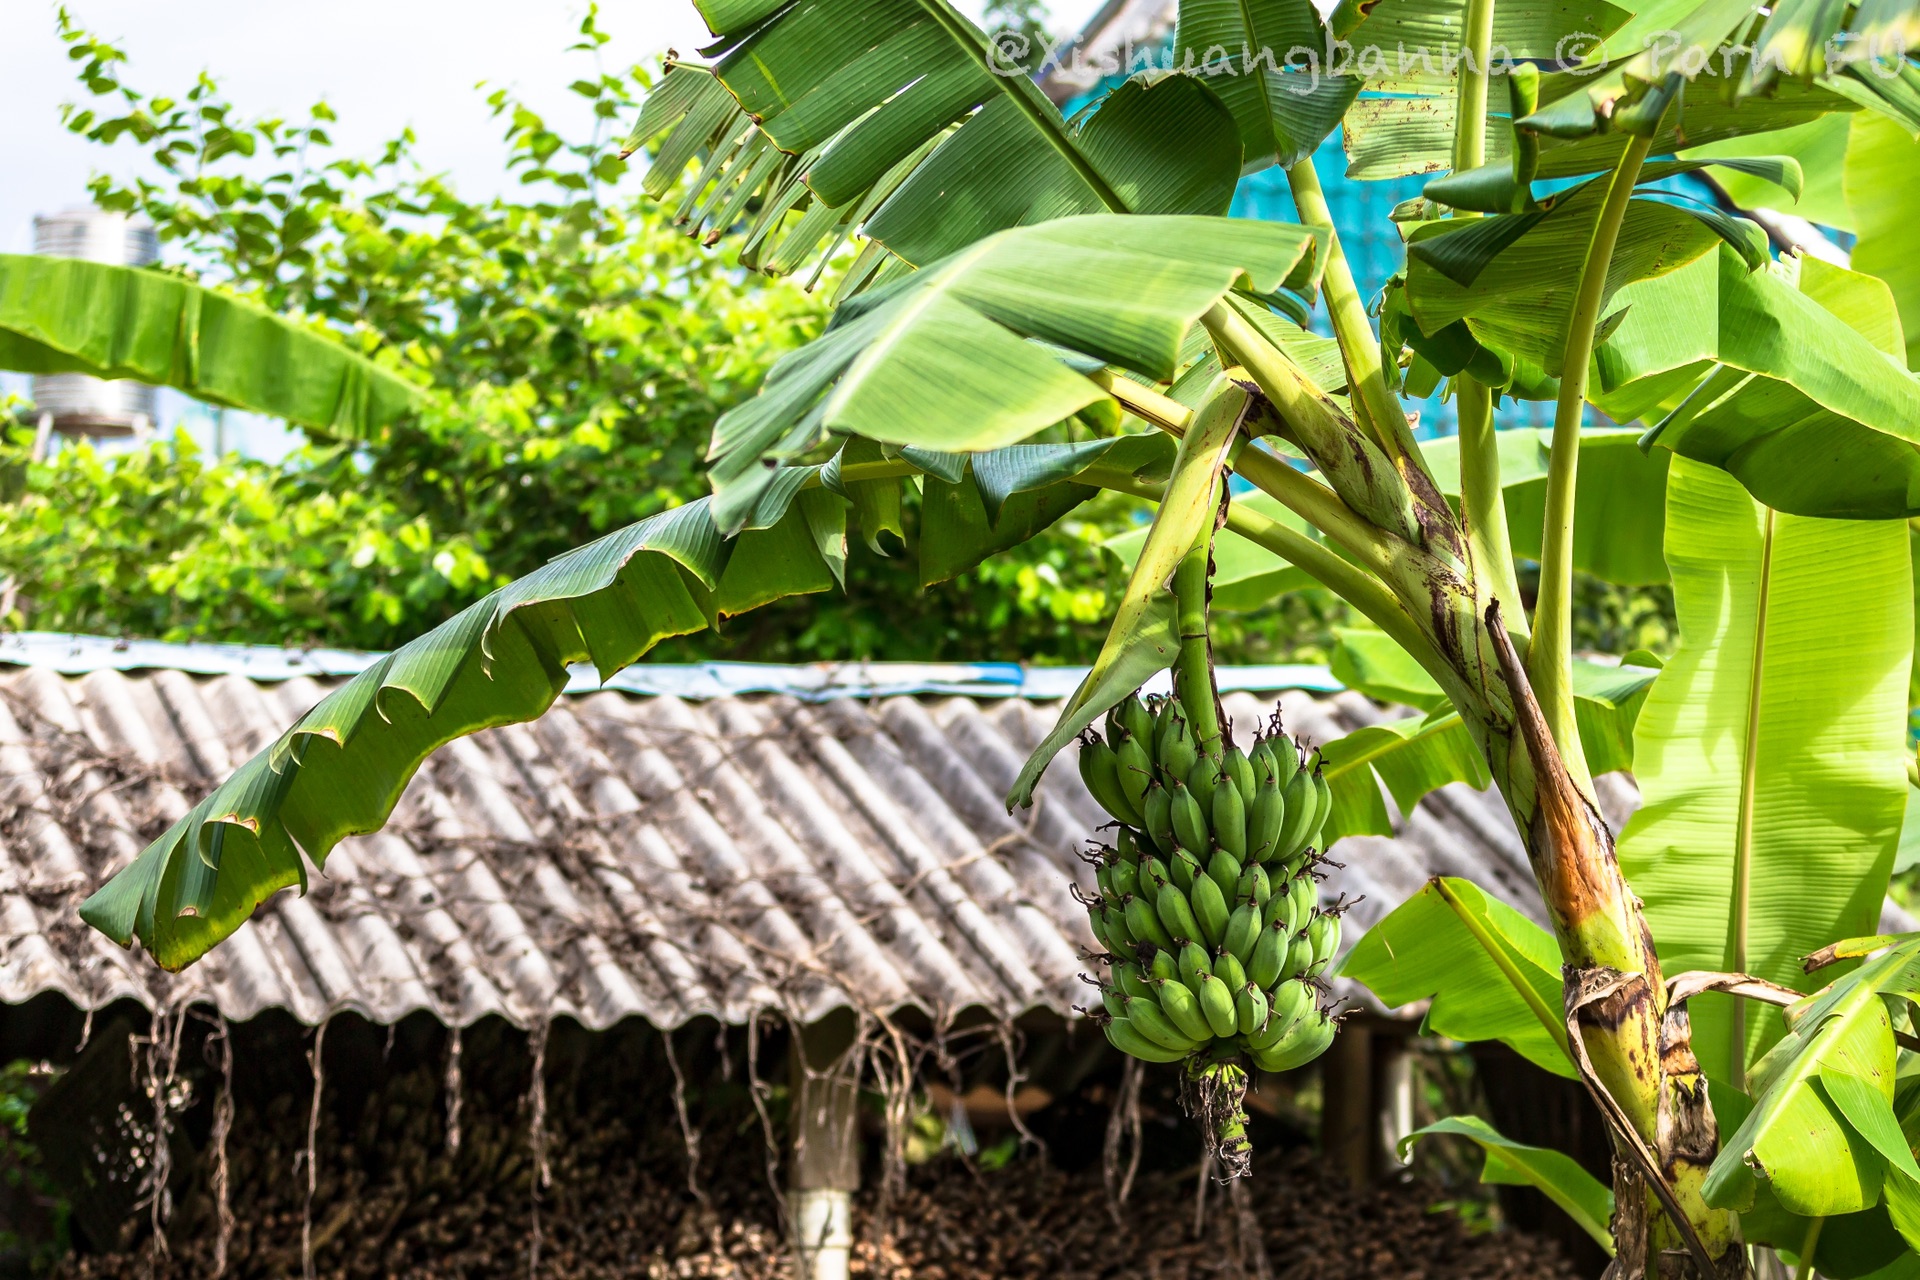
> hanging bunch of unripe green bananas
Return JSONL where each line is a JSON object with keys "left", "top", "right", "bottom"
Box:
{"left": 1079, "top": 695, "right": 1340, "bottom": 1071}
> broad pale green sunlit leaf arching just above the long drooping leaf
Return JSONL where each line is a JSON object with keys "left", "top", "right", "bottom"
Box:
{"left": 710, "top": 215, "right": 1317, "bottom": 530}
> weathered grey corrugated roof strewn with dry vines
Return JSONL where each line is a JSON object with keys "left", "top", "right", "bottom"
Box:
{"left": 0, "top": 666, "right": 1904, "bottom": 1029}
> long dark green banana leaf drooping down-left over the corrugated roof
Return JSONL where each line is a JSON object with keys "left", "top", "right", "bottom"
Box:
{"left": 81, "top": 486, "right": 847, "bottom": 969}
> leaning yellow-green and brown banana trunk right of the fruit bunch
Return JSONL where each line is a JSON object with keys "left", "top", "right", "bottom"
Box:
{"left": 1206, "top": 307, "right": 1747, "bottom": 1280}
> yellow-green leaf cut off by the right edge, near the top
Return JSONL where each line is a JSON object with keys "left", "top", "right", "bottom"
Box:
{"left": 1845, "top": 113, "right": 1920, "bottom": 368}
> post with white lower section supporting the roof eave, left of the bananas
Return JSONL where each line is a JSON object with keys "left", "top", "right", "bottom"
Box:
{"left": 789, "top": 1009, "right": 860, "bottom": 1280}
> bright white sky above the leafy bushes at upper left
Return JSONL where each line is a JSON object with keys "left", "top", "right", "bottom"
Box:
{"left": 0, "top": 0, "right": 1098, "bottom": 253}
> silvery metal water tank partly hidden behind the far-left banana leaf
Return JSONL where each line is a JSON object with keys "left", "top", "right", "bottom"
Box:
{"left": 33, "top": 205, "right": 159, "bottom": 451}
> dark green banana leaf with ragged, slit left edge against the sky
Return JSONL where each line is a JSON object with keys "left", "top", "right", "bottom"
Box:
{"left": 628, "top": 0, "right": 1240, "bottom": 271}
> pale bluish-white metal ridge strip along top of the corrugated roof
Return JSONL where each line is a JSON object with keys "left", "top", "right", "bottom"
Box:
{"left": 0, "top": 631, "right": 1346, "bottom": 700}
